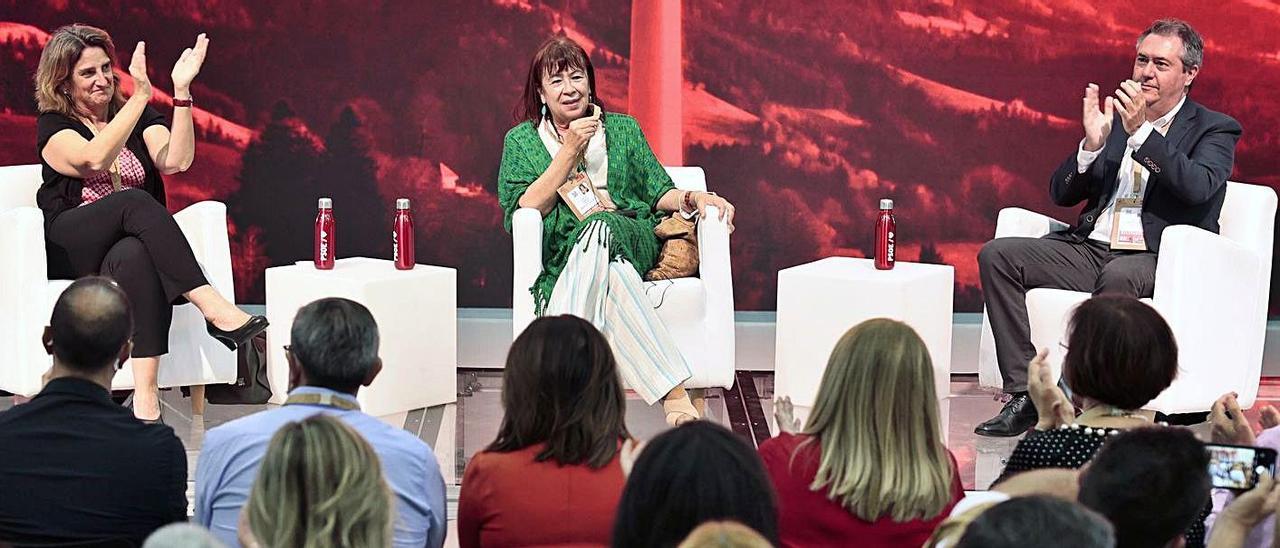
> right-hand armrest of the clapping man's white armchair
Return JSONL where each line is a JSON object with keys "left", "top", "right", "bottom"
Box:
{"left": 1148, "top": 225, "right": 1270, "bottom": 412}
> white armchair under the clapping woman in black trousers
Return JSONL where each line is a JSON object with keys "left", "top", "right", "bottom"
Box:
{"left": 0, "top": 165, "right": 236, "bottom": 396}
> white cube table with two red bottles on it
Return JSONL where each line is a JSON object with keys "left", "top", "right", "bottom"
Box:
{"left": 266, "top": 257, "right": 458, "bottom": 416}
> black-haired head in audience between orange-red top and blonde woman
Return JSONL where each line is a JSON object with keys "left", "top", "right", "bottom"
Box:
{"left": 613, "top": 421, "right": 778, "bottom": 548}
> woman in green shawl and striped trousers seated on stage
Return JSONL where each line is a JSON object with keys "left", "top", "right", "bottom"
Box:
{"left": 498, "top": 36, "right": 733, "bottom": 424}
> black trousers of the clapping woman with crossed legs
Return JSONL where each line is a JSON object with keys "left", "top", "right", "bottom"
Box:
{"left": 45, "top": 188, "right": 209, "bottom": 357}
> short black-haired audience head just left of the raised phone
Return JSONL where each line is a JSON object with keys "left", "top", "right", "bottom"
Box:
{"left": 1079, "top": 426, "right": 1210, "bottom": 548}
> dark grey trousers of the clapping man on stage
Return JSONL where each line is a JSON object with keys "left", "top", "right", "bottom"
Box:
{"left": 978, "top": 234, "right": 1156, "bottom": 392}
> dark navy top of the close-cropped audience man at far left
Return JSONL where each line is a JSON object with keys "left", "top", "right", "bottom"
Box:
{"left": 0, "top": 378, "right": 187, "bottom": 545}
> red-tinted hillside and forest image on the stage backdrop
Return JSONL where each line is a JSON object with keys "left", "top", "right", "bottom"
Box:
{"left": 0, "top": 0, "right": 1280, "bottom": 314}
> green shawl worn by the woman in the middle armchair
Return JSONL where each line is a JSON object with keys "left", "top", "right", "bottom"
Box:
{"left": 498, "top": 113, "right": 675, "bottom": 315}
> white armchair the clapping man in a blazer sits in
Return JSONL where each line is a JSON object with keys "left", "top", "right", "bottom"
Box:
{"left": 978, "top": 182, "right": 1276, "bottom": 414}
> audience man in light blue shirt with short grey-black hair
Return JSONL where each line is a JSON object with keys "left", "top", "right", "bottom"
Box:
{"left": 196, "top": 298, "right": 445, "bottom": 548}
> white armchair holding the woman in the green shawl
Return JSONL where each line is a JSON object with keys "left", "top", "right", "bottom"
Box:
{"left": 511, "top": 168, "right": 735, "bottom": 388}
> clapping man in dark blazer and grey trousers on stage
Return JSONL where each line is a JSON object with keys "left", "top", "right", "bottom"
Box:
{"left": 974, "top": 19, "right": 1240, "bottom": 437}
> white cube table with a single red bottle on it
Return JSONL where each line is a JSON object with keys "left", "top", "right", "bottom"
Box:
{"left": 773, "top": 257, "right": 955, "bottom": 435}
